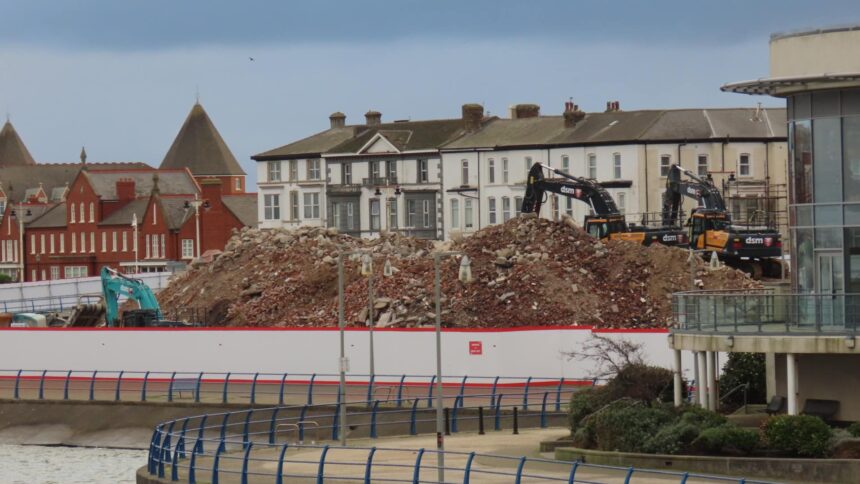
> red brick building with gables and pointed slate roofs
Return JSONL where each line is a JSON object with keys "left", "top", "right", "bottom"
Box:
{"left": 0, "top": 104, "right": 257, "bottom": 281}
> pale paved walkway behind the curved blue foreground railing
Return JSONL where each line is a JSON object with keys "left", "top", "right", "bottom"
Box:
{"left": 158, "top": 429, "right": 756, "bottom": 484}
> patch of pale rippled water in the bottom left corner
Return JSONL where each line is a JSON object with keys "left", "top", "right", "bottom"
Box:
{"left": 0, "top": 445, "right": 147, "bottom": 484}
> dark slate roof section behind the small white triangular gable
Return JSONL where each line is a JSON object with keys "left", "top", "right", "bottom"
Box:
{"left": 328, "top": 118, "right": 478, "bottom": 154}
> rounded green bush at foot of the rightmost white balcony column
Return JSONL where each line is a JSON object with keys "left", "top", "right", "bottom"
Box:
{"left": 762, "top": 415, "right": 832, "bottom": 457}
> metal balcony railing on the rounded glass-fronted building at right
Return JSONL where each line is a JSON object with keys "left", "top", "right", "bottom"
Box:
{"left": 672, "top": 289, "right": 860, "bottom": 335}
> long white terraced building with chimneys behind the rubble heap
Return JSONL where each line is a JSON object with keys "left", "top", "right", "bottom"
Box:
{"left": 253, "top": 102, "right": 787, "bottom": 239}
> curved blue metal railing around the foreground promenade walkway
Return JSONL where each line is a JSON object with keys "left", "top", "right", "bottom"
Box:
{"left": 146, "top": 392, "right": 776, "bottom": 484}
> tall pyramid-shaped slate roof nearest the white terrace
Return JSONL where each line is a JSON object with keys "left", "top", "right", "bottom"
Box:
{"left": 161, "top": 103, "right": 245, "bottom": 176}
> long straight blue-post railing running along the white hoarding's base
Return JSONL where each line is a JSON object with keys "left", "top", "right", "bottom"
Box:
{"left": 0, "top": 370, "right": 600, "bottom": 410}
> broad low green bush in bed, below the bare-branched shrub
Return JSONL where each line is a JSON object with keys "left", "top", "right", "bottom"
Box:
{"left": 585, "top": 404, "right": 675, "bottom": 452}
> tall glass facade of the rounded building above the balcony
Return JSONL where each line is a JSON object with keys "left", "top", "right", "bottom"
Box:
{"left": 788, "top": 88, "right": 860, "bottom": 294}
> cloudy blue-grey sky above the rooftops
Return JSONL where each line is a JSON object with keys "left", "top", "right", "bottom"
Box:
{"left": 0, "top": 0, "right": 860, "bottom": 188}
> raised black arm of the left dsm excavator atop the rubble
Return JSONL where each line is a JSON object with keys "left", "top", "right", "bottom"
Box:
{"left": 522, "top": 163, "right": 620, "bottom": 215}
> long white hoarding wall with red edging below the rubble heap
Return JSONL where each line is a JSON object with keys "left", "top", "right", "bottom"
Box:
{"left": 0, "top": 328, "right": 692, "bottom": 379}
